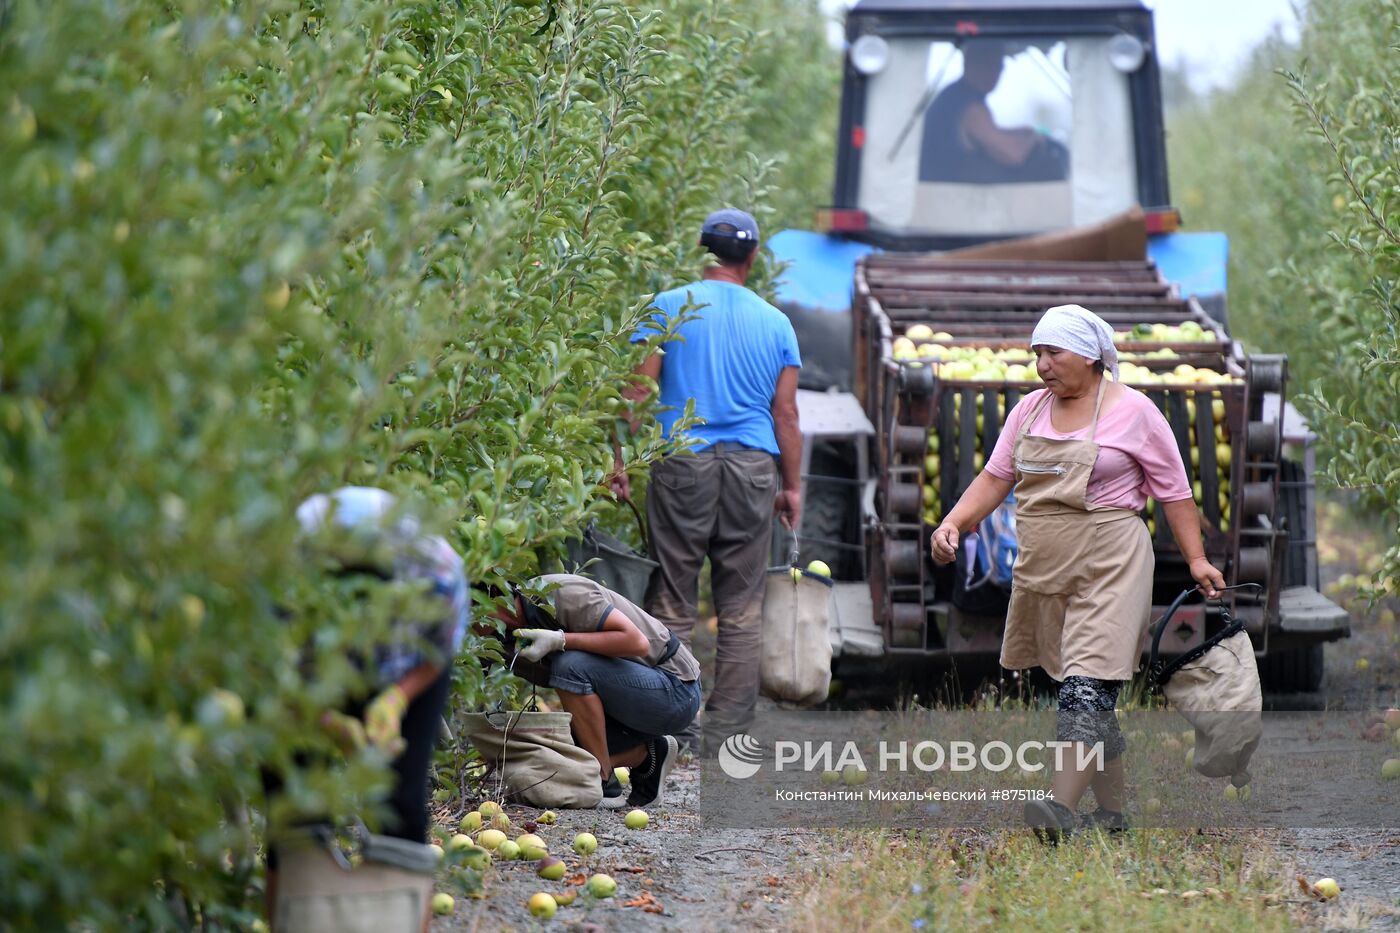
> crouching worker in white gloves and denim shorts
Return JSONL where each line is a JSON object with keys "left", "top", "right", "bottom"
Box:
{"left": 498, "top": 573, "right": 700, "bottom": 808}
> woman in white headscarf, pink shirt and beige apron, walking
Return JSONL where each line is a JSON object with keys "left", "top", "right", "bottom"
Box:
{"left": 931, "top": 305, "right": 1225, "bottom": 842}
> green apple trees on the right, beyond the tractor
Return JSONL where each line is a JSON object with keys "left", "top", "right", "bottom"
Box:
{"left": 1170, "top": 0, "right": 1400, "bottom": 591}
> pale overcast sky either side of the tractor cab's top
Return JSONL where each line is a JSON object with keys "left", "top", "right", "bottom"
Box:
{"left": 822, "top": 0, "right": 1299, "bottom": 91}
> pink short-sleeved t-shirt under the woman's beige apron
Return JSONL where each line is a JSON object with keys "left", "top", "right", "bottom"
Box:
{"left": 987, "top": 387, "right": 1191, "bottom": 511}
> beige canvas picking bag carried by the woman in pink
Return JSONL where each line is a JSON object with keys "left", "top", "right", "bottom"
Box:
{"left": 1149, "top": 584, "right": 1264, "bottom": 787}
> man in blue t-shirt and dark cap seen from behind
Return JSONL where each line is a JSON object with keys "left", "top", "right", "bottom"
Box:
{"left": 615, "top": 209, "right": 802, "bottom": 748}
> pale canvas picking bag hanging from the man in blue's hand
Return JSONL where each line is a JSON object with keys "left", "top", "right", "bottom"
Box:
{"left": 759, "top": 556, "right": 836, "bottom": 706}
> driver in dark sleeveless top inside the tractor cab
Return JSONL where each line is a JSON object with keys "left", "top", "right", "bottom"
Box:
{"left": 918, "top": 41, "right": 1070, "bottom": 185}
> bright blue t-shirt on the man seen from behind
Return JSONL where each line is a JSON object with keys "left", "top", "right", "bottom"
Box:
{"left": 631, "top": 280, "right": 802, "bottom": 455}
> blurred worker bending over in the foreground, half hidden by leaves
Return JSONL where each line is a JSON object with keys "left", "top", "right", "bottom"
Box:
{"left": 265, "top": 486, "right": 469, "bottom": 930}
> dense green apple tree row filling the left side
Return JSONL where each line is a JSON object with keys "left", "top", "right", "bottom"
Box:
{"left": 0, "top": 0, "right": 819, "bottom": 929}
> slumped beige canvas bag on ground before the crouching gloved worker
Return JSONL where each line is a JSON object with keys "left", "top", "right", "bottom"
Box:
{"left": 458, "top": 710, "right": 603, "bottom": 810}
